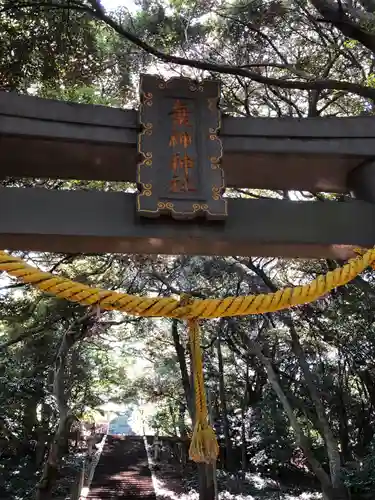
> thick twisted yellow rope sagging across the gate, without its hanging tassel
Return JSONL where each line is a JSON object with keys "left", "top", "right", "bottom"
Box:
{"left": 0, "top": 249, "right": 375, "bottom": 319}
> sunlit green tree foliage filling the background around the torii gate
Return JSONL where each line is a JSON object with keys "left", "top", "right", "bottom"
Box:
{"left": 0, "top": 0, "right": 375, "bottom": 499}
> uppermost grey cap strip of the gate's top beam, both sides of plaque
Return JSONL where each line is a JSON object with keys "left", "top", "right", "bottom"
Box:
{"left": 4, "top": 91, "right": 375, "bottom": 139}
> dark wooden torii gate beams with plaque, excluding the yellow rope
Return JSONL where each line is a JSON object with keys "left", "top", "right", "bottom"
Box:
{"left": 0, "top": 76, "right": 375, "bottom": 258}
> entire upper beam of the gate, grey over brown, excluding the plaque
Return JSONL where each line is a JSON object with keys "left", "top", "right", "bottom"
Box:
{"left": 0, "top": 92, "right": 375, "bottom": 192}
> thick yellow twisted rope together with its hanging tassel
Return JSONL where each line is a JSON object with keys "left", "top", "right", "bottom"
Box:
{"left": 0, "top": 249, "right": 375, "bottom": 463}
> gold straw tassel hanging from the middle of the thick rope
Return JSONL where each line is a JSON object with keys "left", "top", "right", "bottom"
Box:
{"left": 188, "top": 319, "right": 219, "bottom": 464}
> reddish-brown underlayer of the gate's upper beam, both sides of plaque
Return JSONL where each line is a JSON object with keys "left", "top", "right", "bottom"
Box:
{"left": 0, "top": 134, "right": 362, "bottom": 193}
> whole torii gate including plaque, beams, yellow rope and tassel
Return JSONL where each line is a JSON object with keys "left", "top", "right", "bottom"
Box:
{"left": 0, "top": 75, "right": 375, "bottom": 476}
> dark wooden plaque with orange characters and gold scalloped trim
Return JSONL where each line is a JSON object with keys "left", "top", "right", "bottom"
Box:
{"left": 137, "top": 75, "right": 227, "bottom": 219}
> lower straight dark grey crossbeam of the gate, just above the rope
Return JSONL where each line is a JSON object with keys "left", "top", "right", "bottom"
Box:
{"left": 0, "top": 188, "right": 375, "bottom": 258}
